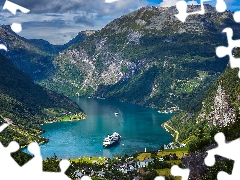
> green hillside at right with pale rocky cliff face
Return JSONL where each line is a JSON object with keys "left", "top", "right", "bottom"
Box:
{"left": 166, "top": 48, "right": 240, "bottom": 179}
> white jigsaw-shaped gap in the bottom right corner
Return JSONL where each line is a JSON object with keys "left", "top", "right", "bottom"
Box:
{"left": 204, "top": 133, "right": 240, "bottom": 180}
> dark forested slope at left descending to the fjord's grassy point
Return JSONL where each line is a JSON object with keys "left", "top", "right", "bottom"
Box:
{"left": 0, "top": 54, "right": 86, "bottom": 146}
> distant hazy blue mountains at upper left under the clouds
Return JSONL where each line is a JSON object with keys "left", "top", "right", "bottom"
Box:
{"left": 0, "top": 25, "right": 91, "bottom": 81}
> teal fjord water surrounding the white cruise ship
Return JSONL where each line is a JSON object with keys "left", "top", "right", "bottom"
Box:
{"left": 41, "top": 97, "right": 172, "bottom": 158}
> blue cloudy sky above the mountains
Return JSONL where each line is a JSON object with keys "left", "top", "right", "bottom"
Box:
{"left": 0, "top": 0, "right": 240, "bottom": 44}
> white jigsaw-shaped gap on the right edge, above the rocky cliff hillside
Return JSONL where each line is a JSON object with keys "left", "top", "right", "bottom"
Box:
{"left": 216, "top": 28, "right": 240, "bottom": 78}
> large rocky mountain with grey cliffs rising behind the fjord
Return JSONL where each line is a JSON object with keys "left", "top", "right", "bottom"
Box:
{"left": 39, "top": 5, "right": 240, "bottom": 111}
